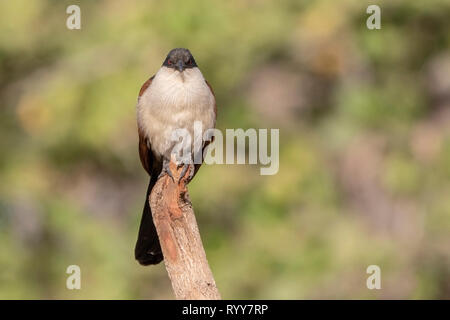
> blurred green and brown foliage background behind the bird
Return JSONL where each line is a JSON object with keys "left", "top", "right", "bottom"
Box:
{"left": 0, "top": 0, "right": 450, "bottom": 299}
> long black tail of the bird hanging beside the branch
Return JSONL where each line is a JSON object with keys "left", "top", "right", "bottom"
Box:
{"left": 134, "top": 175, "right": 163, "bottom": 266}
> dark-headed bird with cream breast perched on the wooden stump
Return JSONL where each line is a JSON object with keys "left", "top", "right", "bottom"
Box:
{"left": 135, "top": 48, "right": 217, "bottom": 266}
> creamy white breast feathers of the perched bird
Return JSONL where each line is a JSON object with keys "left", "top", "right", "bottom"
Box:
{"left": 137, "top": 67, "right": 215, "bottom": 155}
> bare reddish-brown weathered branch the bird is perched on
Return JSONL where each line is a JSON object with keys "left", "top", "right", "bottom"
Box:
{"left": 149, "top": 162, "right": 220, "bottom": 300}
